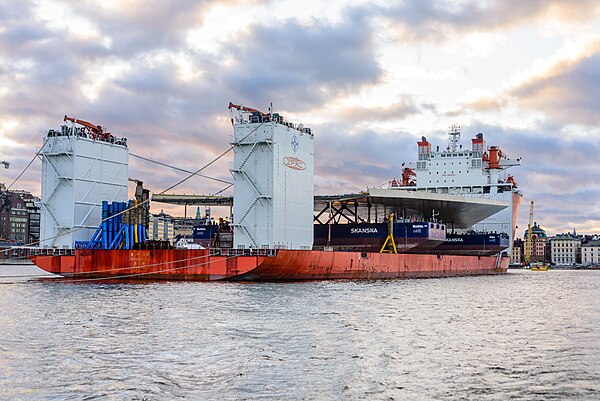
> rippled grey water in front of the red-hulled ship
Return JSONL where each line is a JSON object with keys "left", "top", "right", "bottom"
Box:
{"left": 0, "top": 266, "right": 600, "bottom": 400}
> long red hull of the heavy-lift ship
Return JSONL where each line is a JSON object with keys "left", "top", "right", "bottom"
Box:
{"left": 31, "top": 249, "right": 510, "bottom": 281}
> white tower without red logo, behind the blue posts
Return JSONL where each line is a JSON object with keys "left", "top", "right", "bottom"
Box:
{"left": 40, "top": 124, "right": 129, "bottom": 248}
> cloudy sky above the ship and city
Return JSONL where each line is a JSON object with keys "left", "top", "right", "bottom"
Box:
{"left": 0, "top": 0, "right": 600, "bottom": 234}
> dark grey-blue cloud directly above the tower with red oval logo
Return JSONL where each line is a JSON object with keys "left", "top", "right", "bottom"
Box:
{"left": 222, "top": 14, "right": 383, "bottom": 111}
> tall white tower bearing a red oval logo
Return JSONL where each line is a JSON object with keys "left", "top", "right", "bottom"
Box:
{"left": 230, "top": 105, "right": 314, "bottom": 249}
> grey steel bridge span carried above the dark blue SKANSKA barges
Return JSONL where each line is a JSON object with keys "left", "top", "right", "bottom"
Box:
{"left": 152, "top": 188, "right": 510, "bottom": 228}
